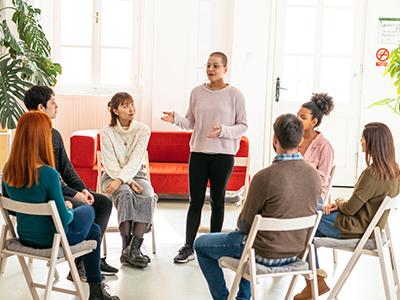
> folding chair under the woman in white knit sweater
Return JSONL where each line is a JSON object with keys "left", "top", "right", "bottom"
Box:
{"left": 96, "top": 151, "right": 157, "bottom": 256}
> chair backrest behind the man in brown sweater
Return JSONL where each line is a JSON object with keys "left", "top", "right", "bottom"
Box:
{"left": 243, "top": 211, "right": 321, "bottom": 260}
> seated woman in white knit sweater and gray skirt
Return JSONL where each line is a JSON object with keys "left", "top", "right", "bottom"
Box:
{"left": 100, "top": 93, "right": 157, "bottom": 268}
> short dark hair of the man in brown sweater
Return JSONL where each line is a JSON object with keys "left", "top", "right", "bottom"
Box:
{"left": 274, "top": 114, "right": 303, "bottom": 149}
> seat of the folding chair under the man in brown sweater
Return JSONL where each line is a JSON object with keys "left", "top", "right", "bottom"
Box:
{"left": 219, "top": 256, "right": 309, "bottom": 275}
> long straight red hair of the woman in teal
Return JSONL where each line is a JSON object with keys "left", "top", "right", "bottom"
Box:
{"left": 4, "top": 111, "right": 55, "bottom": 188}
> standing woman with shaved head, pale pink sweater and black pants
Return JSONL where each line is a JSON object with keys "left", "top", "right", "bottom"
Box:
{"left": 161, "top": 52, "right": 247, "bottom": 263}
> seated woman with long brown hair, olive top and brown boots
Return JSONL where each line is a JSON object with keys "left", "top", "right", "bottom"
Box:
{"left": 294, "top": 123, "right": 400, "bottom": 300}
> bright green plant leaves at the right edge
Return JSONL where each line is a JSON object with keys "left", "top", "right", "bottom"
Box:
{"left": 368, "top": 45, "right": 400, "bottom": 116}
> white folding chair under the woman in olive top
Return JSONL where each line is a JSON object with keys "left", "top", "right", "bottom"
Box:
{"left": 314, "top": 196, "right": 400, "bottom": 299}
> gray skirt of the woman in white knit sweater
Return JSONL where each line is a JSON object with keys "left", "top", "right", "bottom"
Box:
{"left": 101, "top": 169, "right": 158, "bottom": 225}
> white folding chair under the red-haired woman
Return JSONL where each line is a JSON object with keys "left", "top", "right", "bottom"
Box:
{"left": 0, "top": 196, "right": 97, "bottom": 300}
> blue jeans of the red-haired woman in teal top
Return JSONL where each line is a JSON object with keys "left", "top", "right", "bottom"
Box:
{"left": 66, "top": 205, "right": 101, "bottom": 283}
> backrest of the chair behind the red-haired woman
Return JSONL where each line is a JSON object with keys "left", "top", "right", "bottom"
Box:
{"left": 0, "top": 196, "right": 72, "bottom": 256}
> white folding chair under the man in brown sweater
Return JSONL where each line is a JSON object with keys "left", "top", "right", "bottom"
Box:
{"left": 219, "top": 212, "right": 321, "bottom": 300}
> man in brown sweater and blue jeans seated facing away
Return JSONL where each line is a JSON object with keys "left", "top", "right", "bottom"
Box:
{"left": 195, "top": 114, "right": 322, "bottom": 300}
